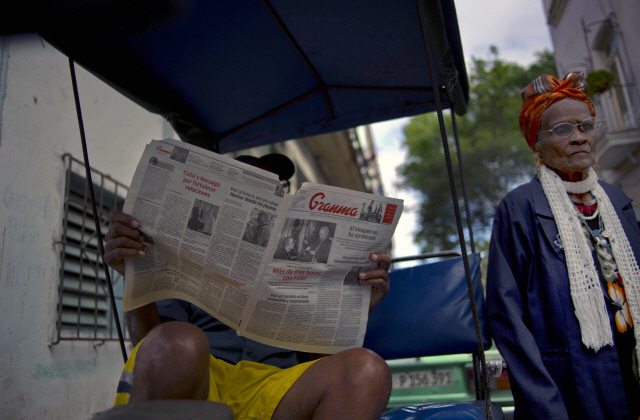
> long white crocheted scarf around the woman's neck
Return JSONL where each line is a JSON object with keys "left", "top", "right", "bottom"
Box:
{"left": 540, "top": 165, "right": 640, "bottom": 359}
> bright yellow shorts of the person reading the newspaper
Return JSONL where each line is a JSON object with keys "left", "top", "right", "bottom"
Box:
{"left": 114, "top": 341, "right": 316, "bottom": 420}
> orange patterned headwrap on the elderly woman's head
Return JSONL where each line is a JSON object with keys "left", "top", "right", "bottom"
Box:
{"left": 519, "top": 71, "right": 596, "bottom": 150}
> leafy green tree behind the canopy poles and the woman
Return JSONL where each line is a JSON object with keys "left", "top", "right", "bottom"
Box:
{"left": 398, "top": 46, "right": 556, "bottom": 252}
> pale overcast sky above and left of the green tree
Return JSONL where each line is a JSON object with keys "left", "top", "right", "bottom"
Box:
{"left": 371, "top": 0, "right": 553, "bottom": 267}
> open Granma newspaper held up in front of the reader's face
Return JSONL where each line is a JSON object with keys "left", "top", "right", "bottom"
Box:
{"left": 123, "top": 139, "right": 403, "bottom": 354}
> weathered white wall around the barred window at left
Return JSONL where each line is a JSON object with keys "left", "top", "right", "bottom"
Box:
{"left": 0, "top": 35, "right": 175, "bottom": 419}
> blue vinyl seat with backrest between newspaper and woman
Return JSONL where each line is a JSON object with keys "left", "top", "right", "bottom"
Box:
{"left": 364, "top": 254, "right": 504, "bottom": 420}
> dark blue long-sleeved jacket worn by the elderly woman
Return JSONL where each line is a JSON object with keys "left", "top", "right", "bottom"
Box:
{"left": 487, "top": 178, "right": 640, "bottom": 420}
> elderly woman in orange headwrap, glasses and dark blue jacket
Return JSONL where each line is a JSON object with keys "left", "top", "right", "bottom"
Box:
{"left": 487, "top": 72, "right": 640, "bottom": 420}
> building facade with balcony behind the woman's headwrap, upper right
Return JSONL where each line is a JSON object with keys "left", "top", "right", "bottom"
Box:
{"left": 542, "top": 0, "right": 640, "bottom": 213}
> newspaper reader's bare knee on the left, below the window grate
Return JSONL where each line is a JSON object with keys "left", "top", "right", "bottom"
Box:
{"left": 129, "top": 322, "right": 209, "bottom": 402}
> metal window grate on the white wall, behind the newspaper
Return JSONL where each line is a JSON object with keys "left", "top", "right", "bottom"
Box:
{"left": 53, "top": 154, "right": 128, "bottom": 344}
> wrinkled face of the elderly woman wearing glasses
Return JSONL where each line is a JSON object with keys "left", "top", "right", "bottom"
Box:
{"left": 535, "top": 99, "right": 597, "bottom": 182}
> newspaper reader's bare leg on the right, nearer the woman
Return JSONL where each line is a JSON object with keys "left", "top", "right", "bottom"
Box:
{"left": 272, "top": 348, "right": 391, "bottom": 420}
